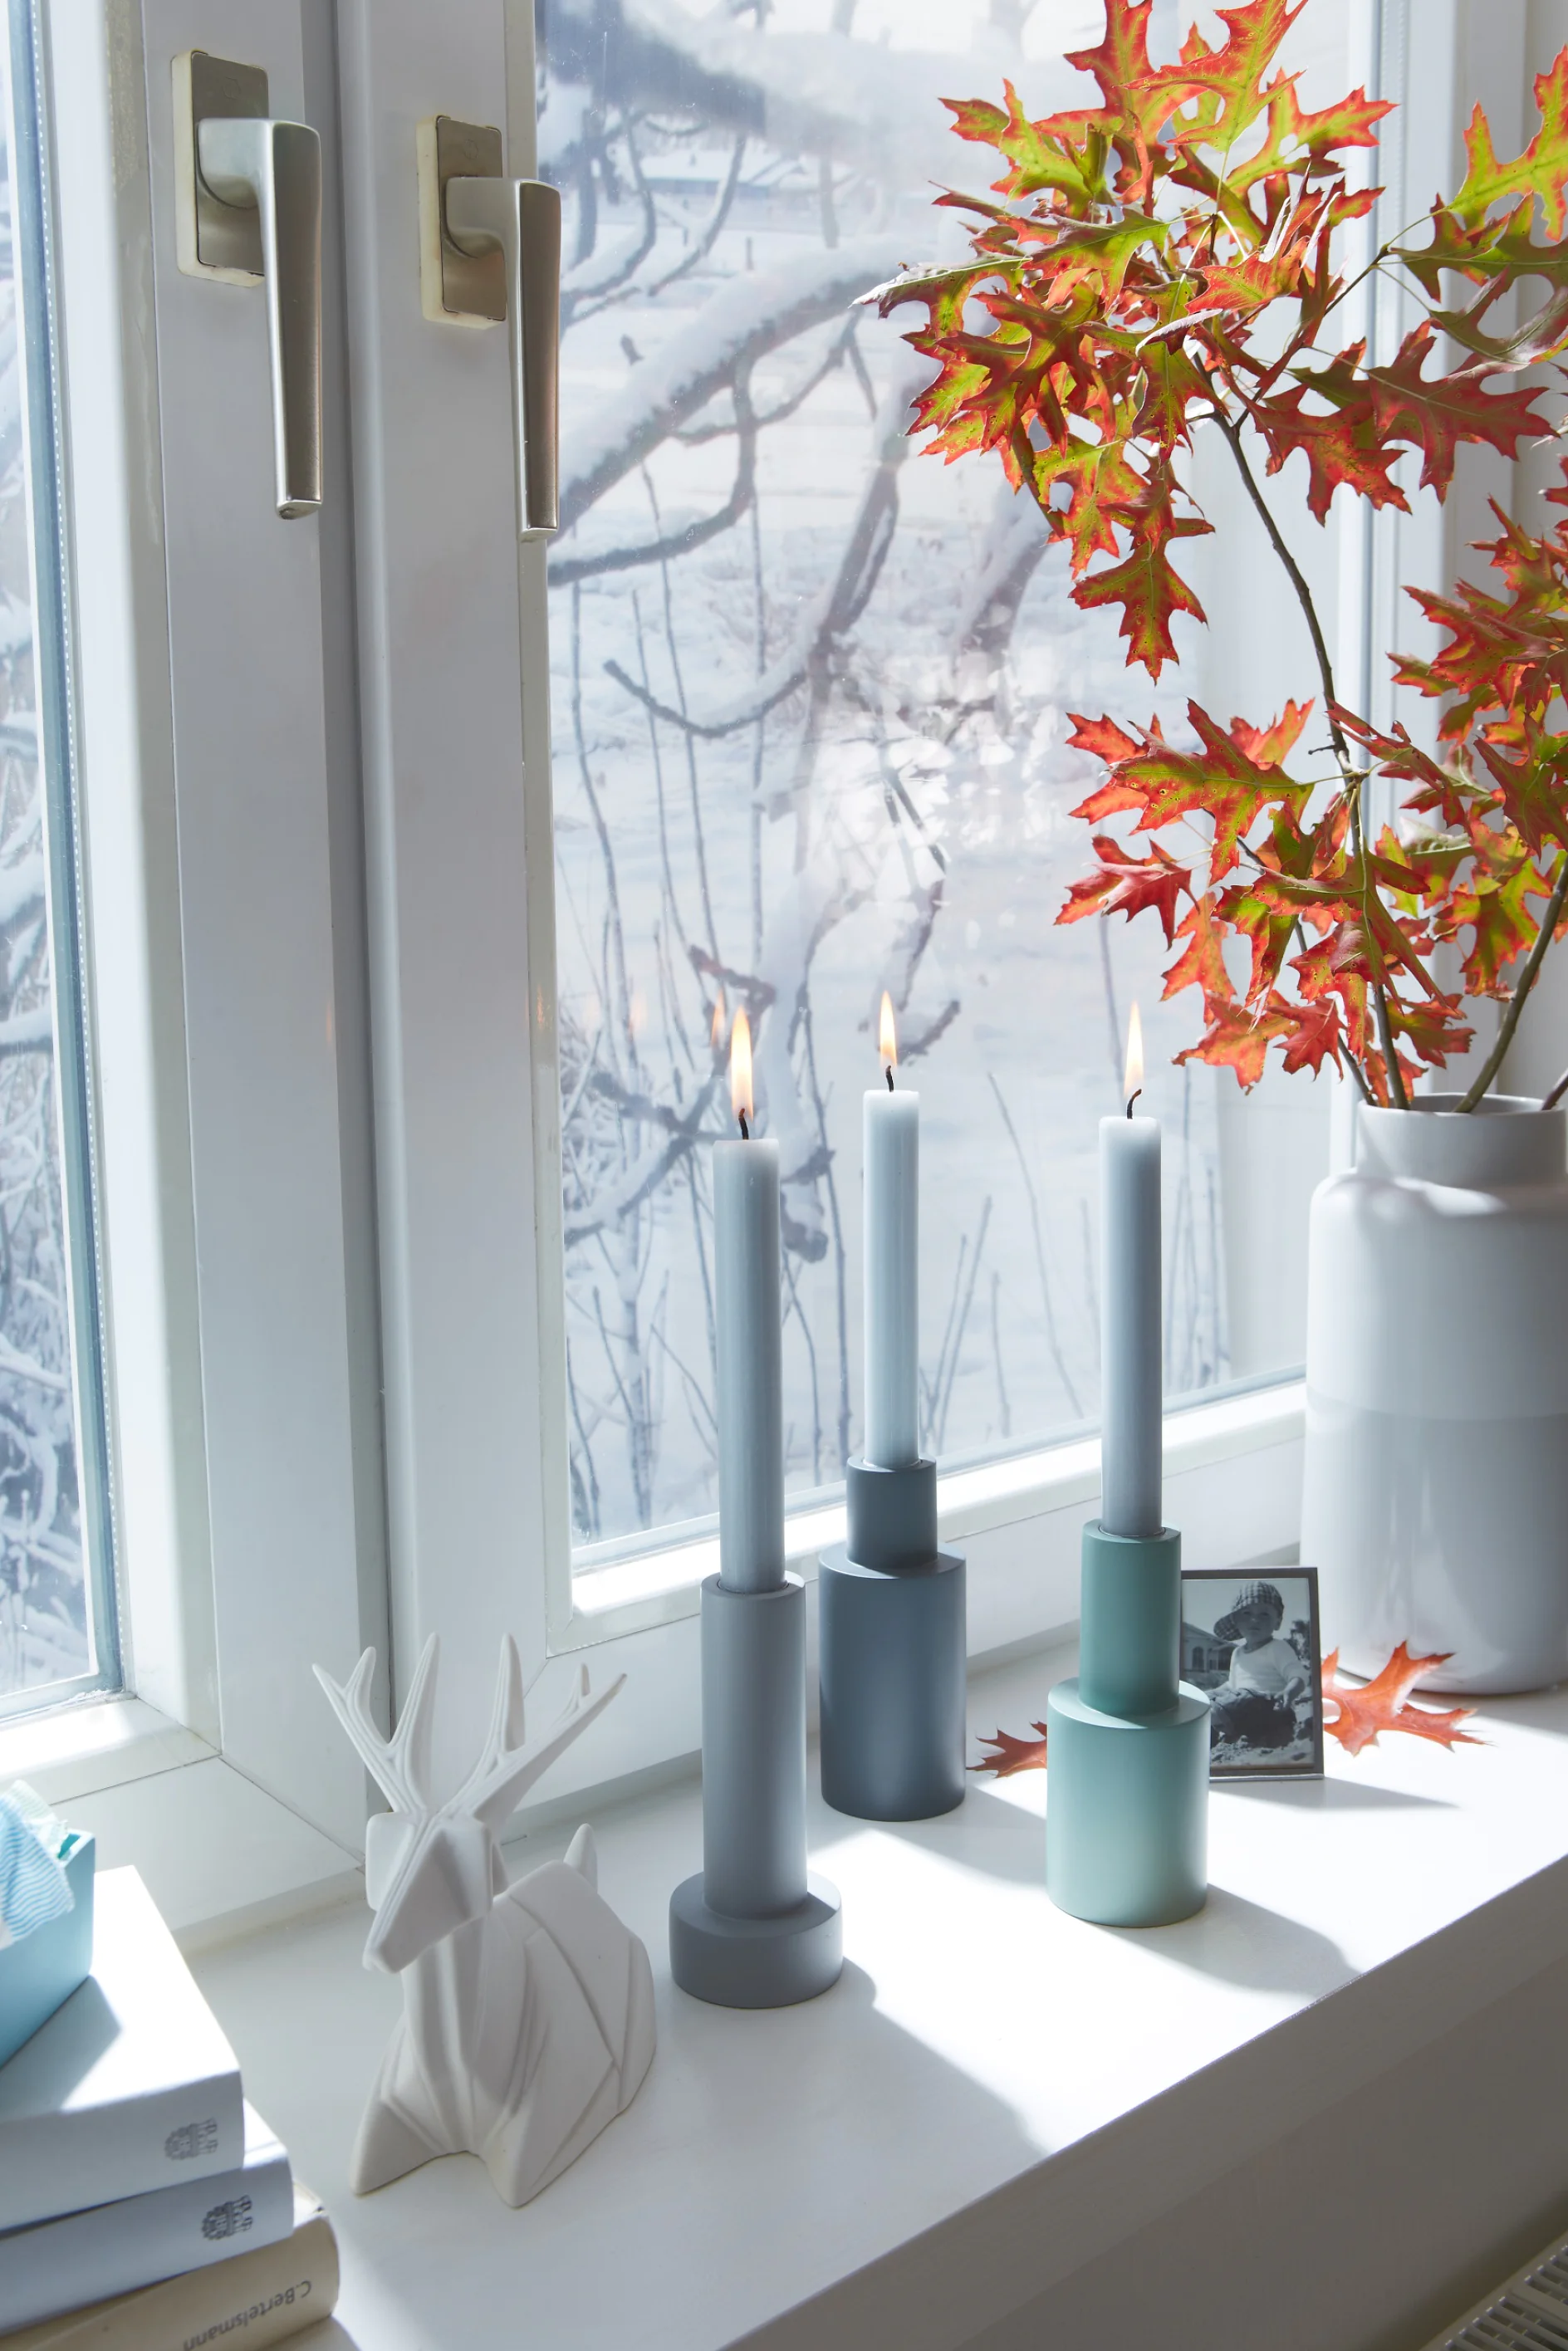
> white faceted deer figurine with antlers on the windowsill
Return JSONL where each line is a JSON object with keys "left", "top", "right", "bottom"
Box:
{"left": 315, "top": 1636, "right": 654, "bottom": 2205}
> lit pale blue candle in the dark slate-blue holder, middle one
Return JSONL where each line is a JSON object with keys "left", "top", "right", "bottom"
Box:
{"left": 863, "top": 995, "right": 919, "bottom": 1469}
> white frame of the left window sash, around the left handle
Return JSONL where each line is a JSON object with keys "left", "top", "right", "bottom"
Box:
{"left": 0, "top": 0, "right": 385, "bottom": 1873}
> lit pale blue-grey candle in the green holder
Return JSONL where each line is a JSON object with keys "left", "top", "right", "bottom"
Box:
{"left": 1100, "top": 1004, "right": 1164, "bottom": 1535}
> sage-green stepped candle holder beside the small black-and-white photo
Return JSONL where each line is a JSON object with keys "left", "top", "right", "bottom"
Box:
{"left": 1046, "top": 1521, "right": 1208, "bottom": 1926}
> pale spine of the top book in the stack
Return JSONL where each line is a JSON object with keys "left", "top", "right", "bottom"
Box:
{"left": 0, "top": 2066, "right": 244, "bottom": 2229}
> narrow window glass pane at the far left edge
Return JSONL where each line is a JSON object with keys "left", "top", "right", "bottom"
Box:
{"left": 0, "top": 0, "right": 118, "bottom": 1712}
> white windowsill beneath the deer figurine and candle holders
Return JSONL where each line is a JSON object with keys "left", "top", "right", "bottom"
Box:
{"left": 187, "top": 1650, "right": 1568, "bottom": 2351}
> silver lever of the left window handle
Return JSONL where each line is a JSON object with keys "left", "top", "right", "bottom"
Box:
{"left": 198, "top": 115, "right": 322, "bottom": 520}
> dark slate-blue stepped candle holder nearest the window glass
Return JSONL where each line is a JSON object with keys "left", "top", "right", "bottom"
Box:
{"left": 816, "top": 1462, "right": 966, "bottom": 1820}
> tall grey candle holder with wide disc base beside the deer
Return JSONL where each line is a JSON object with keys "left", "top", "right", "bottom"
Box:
{"left": 670, "top": 1575, "right": 844, "bottom": 2008}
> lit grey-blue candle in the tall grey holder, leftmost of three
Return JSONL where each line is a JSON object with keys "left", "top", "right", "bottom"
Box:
{"left": 713, "top": 1011, "right": 785, "bottom": 1592}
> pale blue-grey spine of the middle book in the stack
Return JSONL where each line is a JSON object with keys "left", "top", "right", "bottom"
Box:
{"left": 0, "top": 2142, "right": 294, "bottom": 2328}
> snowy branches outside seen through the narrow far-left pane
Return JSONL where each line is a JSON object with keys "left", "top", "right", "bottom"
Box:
{"left": 0, "top": 55, "right": 94, "bottom": 1702}
